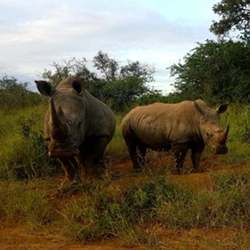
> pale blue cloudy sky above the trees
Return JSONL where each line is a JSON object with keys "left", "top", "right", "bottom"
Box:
{"left": 0, "top": 0, "right": 218, "bottom": 93}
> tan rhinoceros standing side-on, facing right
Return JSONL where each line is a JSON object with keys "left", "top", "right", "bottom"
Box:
{"left": 121, "top": 99, "right": 229, "bottom": 174}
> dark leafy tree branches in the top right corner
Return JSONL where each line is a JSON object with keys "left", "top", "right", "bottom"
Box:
{"left": 210, "top": 0, "right": 250, "bottom": 43}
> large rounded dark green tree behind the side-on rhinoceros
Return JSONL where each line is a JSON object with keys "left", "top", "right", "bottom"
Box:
{"left": 170, "top": 41, "right": 250, "bottom": 102}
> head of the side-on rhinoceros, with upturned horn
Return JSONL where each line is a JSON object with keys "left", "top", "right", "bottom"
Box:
{"left": 194, "top": 100, "right": 229, "bottom": 154}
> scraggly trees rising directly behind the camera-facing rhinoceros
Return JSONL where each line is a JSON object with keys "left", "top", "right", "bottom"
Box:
{"left": 42, "top": 51, "right": 154, "bottom": 111}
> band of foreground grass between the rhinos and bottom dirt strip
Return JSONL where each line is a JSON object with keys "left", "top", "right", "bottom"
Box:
{"left": 0, "top": 169, "right": 250, "bottom": 244}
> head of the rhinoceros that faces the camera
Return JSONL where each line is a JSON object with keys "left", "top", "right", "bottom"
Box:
{"left": 35, "top": 78, "right": 86, "bottom": 157}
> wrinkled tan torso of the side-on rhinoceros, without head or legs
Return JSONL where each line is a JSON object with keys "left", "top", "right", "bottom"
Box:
{"left": 122, "top": 101, "right": 199, "bottom": 145}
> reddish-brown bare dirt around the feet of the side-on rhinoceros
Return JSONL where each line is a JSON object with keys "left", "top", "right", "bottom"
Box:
{"left": 110, "top": 154, "right": 250, "bottom": 191}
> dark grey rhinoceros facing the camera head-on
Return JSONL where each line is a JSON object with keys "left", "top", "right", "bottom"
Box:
{"left": 35, "top": 77, "right": 115, "bottom": 187}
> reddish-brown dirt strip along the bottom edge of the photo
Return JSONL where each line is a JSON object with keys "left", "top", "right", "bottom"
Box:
{"left": 0, "top": 226, "right": 250, "bottom": 250}
